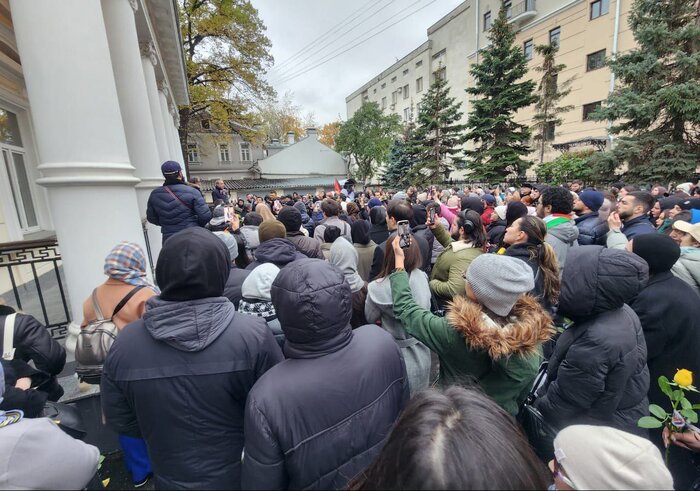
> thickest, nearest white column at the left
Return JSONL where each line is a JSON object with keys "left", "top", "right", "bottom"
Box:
{"left": 11, "top": 0, "right": 144, "bottom": 323}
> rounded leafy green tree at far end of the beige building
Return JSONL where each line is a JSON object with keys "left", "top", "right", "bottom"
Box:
{"left": 335, "top": 102, "right": 401, "bottom": 181}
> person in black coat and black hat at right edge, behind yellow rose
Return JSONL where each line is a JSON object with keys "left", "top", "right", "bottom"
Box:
{"left": 627, "top": 234, "right": 700, "bottom": 489}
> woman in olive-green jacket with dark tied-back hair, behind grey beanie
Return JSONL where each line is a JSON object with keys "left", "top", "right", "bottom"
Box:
{"left": 428, "top": 210, "right": 488, "bottom": 304}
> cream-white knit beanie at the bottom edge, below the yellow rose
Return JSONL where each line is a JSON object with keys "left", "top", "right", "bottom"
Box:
{"left": 554, "top": 425, "right": 673, "bottom": 490}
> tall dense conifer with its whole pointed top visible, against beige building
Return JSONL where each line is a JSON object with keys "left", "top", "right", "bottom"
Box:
{"left": 466, "top": 3, "right": 537, "bottom": 182}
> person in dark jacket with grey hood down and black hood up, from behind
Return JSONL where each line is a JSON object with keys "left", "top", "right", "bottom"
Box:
{"left": 101, "top": 228, "right": 283, "bottom": 489}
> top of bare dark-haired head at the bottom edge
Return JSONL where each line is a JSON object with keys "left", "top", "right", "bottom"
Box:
{"left": 348, "top": 386, "right": 552, "bottom": 490}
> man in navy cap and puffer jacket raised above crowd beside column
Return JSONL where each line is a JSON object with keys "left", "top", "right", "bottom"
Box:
{"left": 146, "top": 160, "right": 211, "bottom": 243}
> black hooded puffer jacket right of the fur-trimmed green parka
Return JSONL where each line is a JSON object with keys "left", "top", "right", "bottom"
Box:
{"left": 535, "top": 246, "right": 649, "bottom": 434}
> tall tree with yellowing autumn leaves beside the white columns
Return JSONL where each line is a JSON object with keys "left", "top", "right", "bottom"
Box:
{"left": 178, "top": 0, "right": 274, "bottom": 164}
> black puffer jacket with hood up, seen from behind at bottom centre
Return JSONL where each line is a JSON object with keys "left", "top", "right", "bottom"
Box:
{"left": 243, "top": 259, "right": 408, "bottom": 489}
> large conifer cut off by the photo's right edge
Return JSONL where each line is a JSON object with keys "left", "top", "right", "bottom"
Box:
{"left": 594, "top": 0, "right": 700, "bottom": 181}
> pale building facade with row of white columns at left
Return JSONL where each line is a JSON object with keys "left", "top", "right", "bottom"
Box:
{"left": 0, "top": 0, "right": 188, "bottom": 336}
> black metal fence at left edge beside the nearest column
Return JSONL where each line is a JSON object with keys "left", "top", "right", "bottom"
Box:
{"left": 0, "top": 238, "right": 71, "bottom": 339}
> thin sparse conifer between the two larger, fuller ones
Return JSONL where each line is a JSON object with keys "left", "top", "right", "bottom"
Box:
{"left": 532, "top": 44, "right": 574, "bottom": 163}
